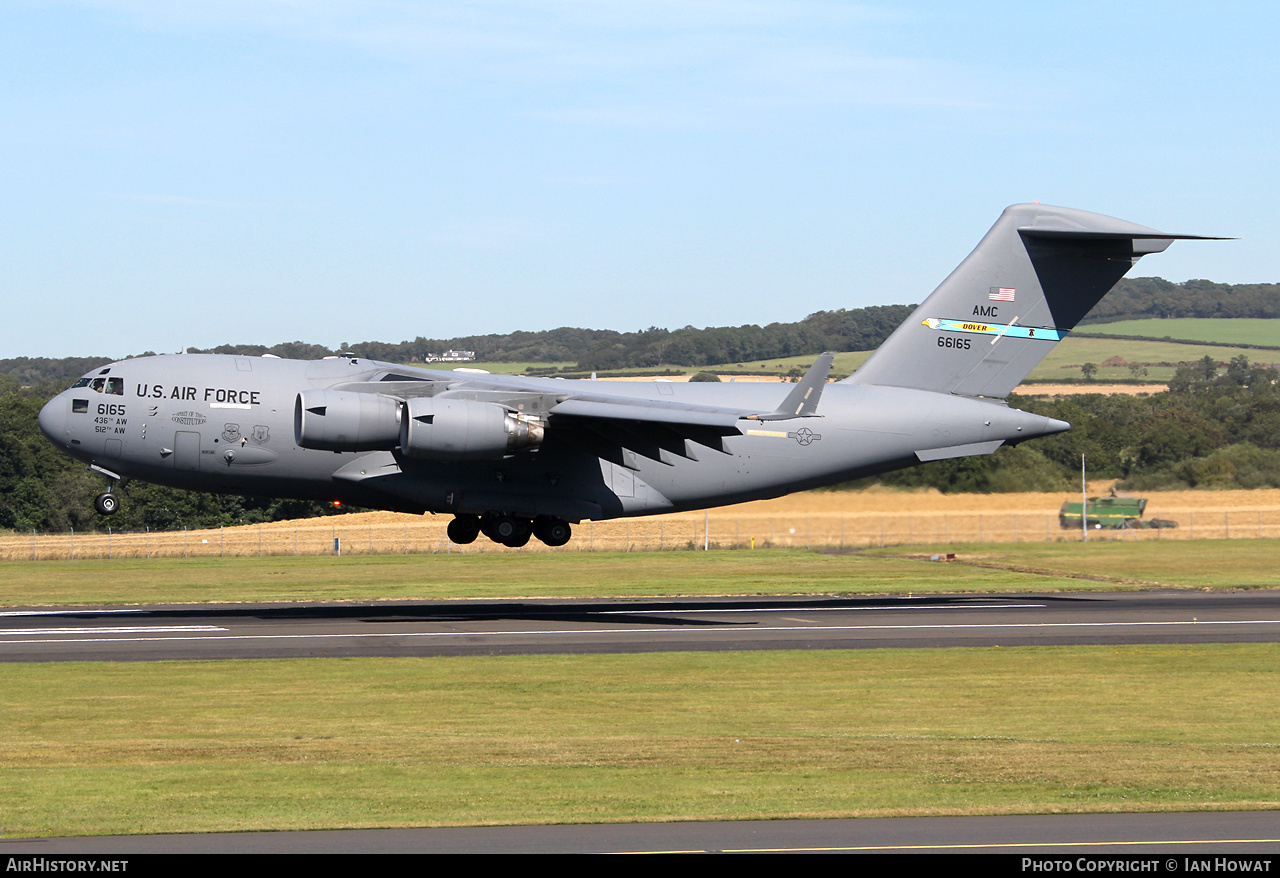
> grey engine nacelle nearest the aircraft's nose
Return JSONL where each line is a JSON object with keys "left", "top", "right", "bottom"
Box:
{"left": 293, "top": 390, "right": 402, "bottom": 452}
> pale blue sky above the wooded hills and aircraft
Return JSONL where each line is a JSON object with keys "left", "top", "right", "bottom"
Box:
{"left": 0, "top": 0, "right": 1280, "bottom": 357}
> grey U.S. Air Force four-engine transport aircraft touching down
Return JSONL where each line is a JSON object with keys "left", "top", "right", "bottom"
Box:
{"left": 40, "top": 204, "right": 1218, "bottom": 547}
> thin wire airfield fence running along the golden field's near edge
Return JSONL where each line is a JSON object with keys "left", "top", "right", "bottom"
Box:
{"left": 0, "top": 507, "right": 1280, "bottom": 561}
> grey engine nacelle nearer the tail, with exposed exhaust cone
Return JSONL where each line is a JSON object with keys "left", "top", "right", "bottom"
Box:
{"left": 399, "top": 397, "right": 543, "bottom": 461}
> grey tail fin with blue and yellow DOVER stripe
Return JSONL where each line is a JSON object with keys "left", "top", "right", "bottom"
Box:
{"left": 845, "top": 205, "right": 1218, "bottom": 397}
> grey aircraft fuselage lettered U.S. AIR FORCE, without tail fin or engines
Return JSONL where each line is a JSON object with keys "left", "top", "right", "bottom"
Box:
{"left": 40, "top": 355, "right": 1066, "bottom": 521}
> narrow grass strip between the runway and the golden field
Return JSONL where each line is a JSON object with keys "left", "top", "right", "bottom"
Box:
{"left": 0, "top": 539, "right": 1280, "bottom": 607}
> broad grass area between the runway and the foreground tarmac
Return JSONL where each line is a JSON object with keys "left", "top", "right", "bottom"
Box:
{"left": 0, "top": 644, "right": 1280, "bottom": 838}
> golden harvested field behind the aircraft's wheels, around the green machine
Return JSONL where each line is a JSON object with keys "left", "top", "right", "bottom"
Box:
{"left": 10, "top": 483, "right": 1280, "bottom": 561}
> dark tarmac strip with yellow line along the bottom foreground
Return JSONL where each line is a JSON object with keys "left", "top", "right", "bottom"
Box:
{"left": 0, "top": 811, "right": 1280, "bottom": 860}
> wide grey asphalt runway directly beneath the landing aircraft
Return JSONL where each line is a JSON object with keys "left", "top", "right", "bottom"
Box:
{"left": 0, "top": 590, "right": 1280, "bottom": 662}
